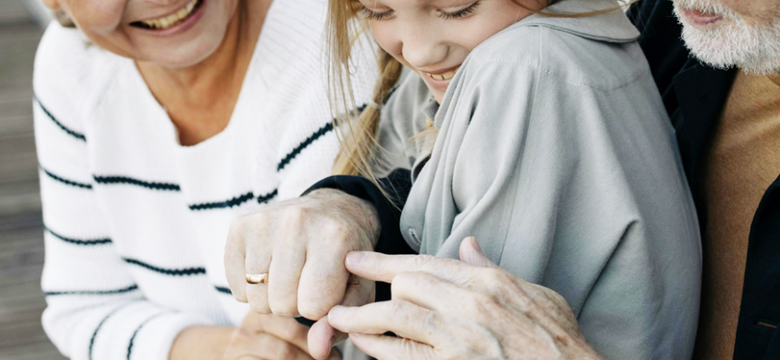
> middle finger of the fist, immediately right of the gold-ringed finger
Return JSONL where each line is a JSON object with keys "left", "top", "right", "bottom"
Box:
{"left": 268, "top": 238, "right": 306, "bottom": 317}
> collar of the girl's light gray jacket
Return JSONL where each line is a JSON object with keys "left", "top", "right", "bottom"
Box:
{"left": 510, "top": 0, "right": 639, "bottom": 43}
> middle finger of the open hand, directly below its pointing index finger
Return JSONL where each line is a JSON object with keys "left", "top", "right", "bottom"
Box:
{"left": 328, "top": 300, "right": 444, "bottom": 346}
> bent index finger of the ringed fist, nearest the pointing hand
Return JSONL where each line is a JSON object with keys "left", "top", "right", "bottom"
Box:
{"left": 298, "top": 241, "right": 349, "bottom": 320}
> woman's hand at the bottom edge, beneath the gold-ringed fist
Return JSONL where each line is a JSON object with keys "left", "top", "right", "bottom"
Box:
{"left": 222, "top": 312, "right": 339, "bottom": 360}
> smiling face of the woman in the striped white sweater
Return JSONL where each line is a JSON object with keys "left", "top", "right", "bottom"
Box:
{"left": 44, "top": 0, "right": 238, "bottom": 69}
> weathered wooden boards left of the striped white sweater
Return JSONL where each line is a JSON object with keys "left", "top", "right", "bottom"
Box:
{"left": 0, "top": 0, "right": 64, "bottom": 360}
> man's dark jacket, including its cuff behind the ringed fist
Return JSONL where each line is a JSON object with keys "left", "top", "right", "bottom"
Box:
{"left": 312, "top": 0, "right": 780, "bottom": 360}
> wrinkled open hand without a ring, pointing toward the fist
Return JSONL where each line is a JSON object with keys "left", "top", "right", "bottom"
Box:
{"left": 328, "top": 238, "right": 599, "bottom": 360}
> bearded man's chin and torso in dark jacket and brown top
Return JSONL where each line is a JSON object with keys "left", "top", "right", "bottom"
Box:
{"left": 630, "top": 0, "right": 780, "bottom": 359}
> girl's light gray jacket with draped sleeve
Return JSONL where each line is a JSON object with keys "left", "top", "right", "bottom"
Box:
{"left": 379, "top": 0, "right": 701, "bottom": 360}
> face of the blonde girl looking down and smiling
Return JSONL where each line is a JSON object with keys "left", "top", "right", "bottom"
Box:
{"left": 359, "top": 0, "right": 541, "bottom": 102}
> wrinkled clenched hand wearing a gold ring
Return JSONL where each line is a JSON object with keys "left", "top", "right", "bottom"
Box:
{"left": 225, "top": 189, "right": 380, "bottom": 358}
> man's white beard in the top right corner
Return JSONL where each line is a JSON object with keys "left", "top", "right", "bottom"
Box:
{"left": 674, "top": 0, "right": 780, "bottom": 75}
